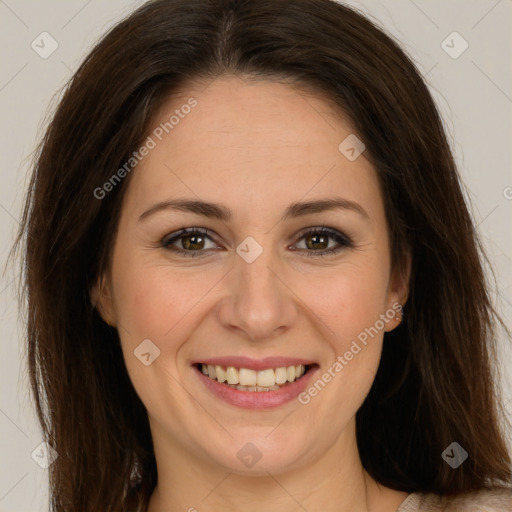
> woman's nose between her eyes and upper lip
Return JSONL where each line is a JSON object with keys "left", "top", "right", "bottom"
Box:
{"left": 218, "top": 241, "right": 299, "bottom": 341}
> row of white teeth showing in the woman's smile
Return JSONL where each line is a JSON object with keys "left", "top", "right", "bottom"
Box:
{"left": 201, "top": 364, "right": 306, "bottom": 391}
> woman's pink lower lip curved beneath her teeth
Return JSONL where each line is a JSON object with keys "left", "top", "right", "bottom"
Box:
{"left": 193, "top": 366, "right": 318, "bottom": 409}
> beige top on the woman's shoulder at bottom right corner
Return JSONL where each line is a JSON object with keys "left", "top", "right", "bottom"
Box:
{"left": 396, "top": 487, "right": 512, "bottom": 512}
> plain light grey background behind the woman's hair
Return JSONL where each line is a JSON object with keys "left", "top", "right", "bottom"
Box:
{"left": 0, "top": 0, "right": 512, "bottom": 512}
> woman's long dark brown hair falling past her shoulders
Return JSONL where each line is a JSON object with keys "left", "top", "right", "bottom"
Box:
{"left": 15, "top": 0, "right": 512, "bottom": 512}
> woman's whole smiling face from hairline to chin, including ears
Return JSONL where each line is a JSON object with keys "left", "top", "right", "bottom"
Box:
{"left": 94, "top": 76, "right": 406, "bottom": 474}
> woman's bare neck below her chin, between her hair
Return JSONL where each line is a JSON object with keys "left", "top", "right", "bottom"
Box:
{"left": 148, "top": 425, "right": 407, "bottom": 512}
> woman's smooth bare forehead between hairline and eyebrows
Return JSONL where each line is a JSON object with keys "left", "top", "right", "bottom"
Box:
{"left": 122, "top": 77, "right": 379, "bottom": 222}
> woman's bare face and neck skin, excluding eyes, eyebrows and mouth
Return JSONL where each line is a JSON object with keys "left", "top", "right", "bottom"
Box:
{"left": 93, "top": 76, "right": 409, "bottom": 512}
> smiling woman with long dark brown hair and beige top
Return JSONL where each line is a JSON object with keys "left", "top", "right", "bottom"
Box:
{"left": 14, "top": 0, "right": 512, "bottom": 512}
